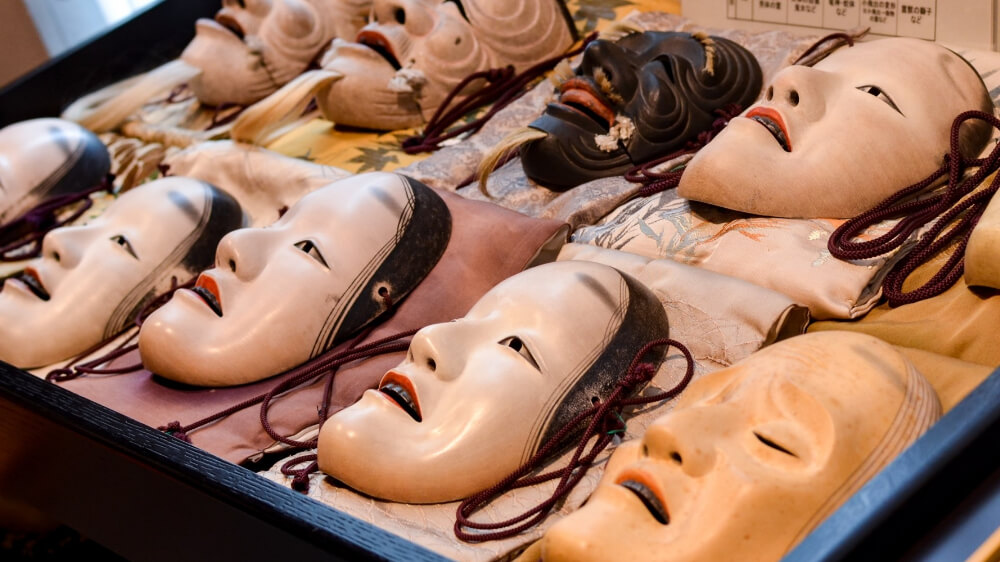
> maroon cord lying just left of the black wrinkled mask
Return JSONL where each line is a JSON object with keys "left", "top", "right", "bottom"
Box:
{"left": 403, "top": 32, "right": 597, "bottom": 154}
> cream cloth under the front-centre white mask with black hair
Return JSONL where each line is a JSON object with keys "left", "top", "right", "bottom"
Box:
{"left": 264, "top": 245, "right": 807, "bottom": 561}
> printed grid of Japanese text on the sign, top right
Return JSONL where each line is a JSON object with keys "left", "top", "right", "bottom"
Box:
{"left": 726, "top": 0, "right": 938, "bottom": 41}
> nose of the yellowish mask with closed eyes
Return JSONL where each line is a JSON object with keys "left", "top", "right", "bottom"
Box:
{"left": 641, "top": 411, "right": 715, "bottom": 478}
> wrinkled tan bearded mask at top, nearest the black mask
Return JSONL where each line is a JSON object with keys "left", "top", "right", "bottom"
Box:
{"left": 316, "top": 0, "right": 574, "bottom": 130}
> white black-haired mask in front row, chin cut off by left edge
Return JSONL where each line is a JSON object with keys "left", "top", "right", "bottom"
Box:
{"left": 0, "top": 178, "right": 243, "bottom": 368}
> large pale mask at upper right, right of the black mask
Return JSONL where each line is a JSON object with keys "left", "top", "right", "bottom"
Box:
{"left": 677, "top": 38, "right": 993, "bottom": 218}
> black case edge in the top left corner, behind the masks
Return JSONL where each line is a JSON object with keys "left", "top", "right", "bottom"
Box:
{"left": 0, "top": 0, "right": 221, "bottom": 127}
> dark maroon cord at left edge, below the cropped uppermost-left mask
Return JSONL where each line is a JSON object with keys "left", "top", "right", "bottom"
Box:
{"left": 0, "top": 174, "right": 115, "bottom": 262}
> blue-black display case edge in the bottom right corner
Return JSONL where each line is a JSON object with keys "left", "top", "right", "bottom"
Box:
{"left": 785, "top": 369, "right": 1000, "bottom": 562}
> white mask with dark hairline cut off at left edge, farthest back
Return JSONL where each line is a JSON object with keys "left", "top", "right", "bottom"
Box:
{"left": 0, "top": 118, "right": 111, "bottom": 224}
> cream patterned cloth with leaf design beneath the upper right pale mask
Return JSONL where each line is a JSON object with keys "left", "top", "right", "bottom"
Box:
{"left": 572, "top": 189, "right": 908, "bottom": 319}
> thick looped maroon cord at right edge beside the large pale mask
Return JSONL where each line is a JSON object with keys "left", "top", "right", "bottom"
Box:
{"left": 827, "top": 111, "right": 1000, "bottom": 307}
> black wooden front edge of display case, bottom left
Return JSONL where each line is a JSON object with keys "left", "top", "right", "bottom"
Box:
{"left": 0, "top": 362, "right": 441, "bottom": 560}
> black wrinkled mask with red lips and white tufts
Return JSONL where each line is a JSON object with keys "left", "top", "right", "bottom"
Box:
{"left": 521, "top": 31, "right": 762, "bottom": 189}
